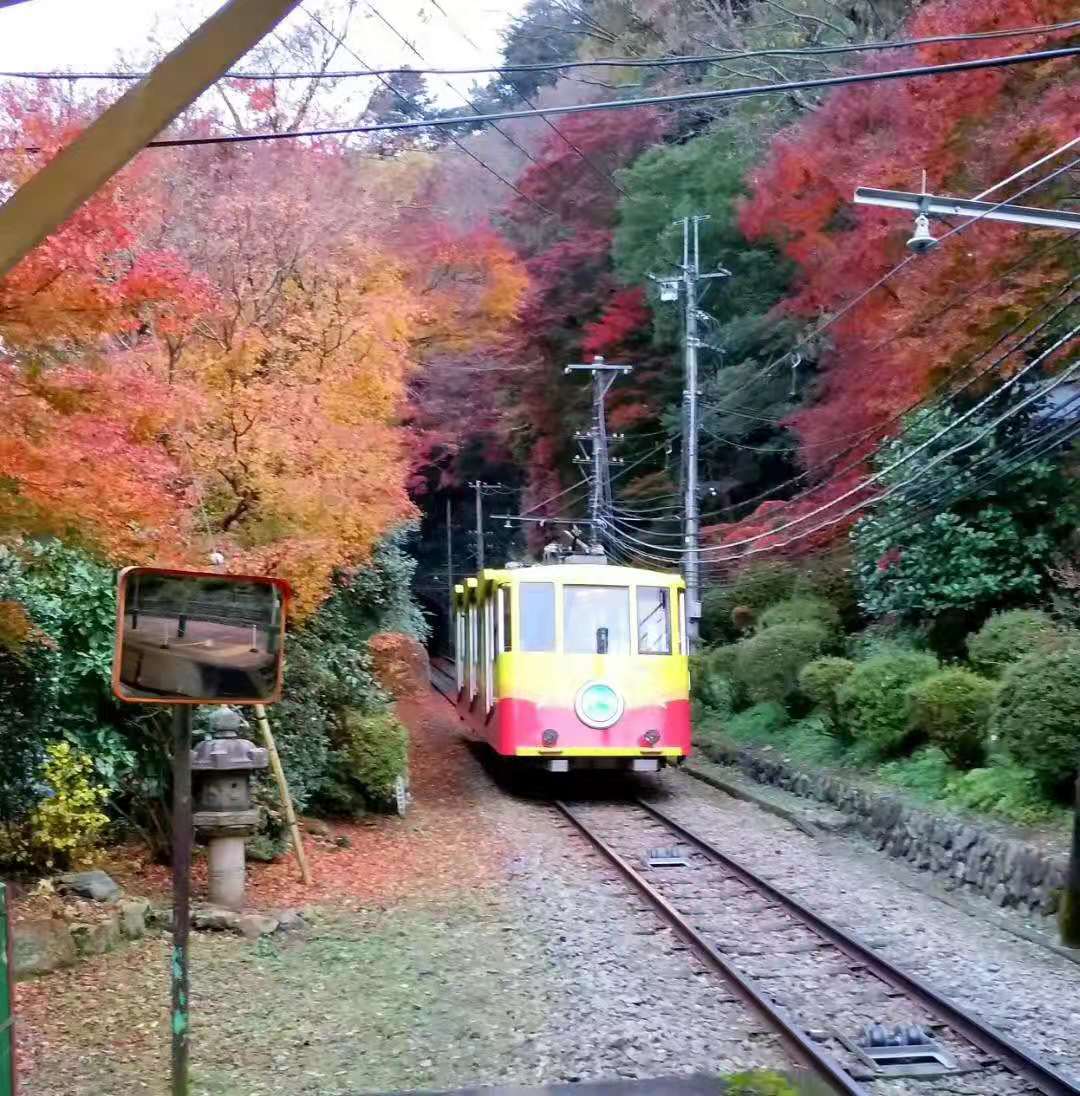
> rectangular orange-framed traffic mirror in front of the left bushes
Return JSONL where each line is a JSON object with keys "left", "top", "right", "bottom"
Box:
{"left": 113, "top": 567, "right": 288, "bottom": 704}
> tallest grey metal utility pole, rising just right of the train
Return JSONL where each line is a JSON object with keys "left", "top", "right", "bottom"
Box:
{"left": 656, "top": 214, "right": 731, "bottom": 650}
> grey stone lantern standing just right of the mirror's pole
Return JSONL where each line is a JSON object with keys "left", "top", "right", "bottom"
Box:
{"left": 191, "top": 707, "right": 269, "bottom": 910}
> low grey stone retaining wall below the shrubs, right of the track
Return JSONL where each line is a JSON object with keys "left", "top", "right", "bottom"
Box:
{"left": 708, "top": 745, "right": 1065, "bottom": 915}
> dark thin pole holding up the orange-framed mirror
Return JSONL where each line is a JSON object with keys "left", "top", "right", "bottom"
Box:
{"left": 170, "top": 704, "right": 195, "bottom": 1096}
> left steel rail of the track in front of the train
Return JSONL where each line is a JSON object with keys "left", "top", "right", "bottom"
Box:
{"left": 553, "top": 799, "right": 867, "bottom": 1096}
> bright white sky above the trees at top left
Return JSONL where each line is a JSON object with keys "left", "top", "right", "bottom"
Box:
{"left": 0, "top": 0, "right": 524, "bottom": 106}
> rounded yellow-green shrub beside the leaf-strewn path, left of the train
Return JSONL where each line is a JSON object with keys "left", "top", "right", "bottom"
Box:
{"left": 322, "top": 709, "right": 409, "bottom": 813}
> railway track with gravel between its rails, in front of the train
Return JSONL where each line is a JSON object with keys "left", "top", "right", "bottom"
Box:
{"left": 555, "top": 800, "right": 1080, "bottom": 1096}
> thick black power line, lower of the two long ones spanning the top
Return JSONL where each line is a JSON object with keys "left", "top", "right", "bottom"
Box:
{"left": 115, "top": 46, "right": 1080, "bottom": 148}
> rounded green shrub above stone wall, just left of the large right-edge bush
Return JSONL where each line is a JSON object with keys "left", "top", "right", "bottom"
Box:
{"left": 907, "top": 669, "right": 997, "bottom": 768}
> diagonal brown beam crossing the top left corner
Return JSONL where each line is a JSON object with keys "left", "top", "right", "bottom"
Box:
{"left": 0, "top": 0, "right": 299, "bottom": 277}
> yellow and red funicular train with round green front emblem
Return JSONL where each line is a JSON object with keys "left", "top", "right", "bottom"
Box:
{"left": 454, "top": 556, "right": 691, "bottom": 773}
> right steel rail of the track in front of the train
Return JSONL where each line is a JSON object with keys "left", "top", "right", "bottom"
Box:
{"left": 630, "top": 800, "right": 1080, "bottom": 1096}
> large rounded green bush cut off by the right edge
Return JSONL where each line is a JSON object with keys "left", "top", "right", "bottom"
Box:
{"left": 990, "top": 646, "right": 1080, "bottom": 792}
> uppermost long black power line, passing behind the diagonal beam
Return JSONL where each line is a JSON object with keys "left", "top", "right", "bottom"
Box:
{"left": 0, "top": 18, "right": 1080, "bottom": 81}
